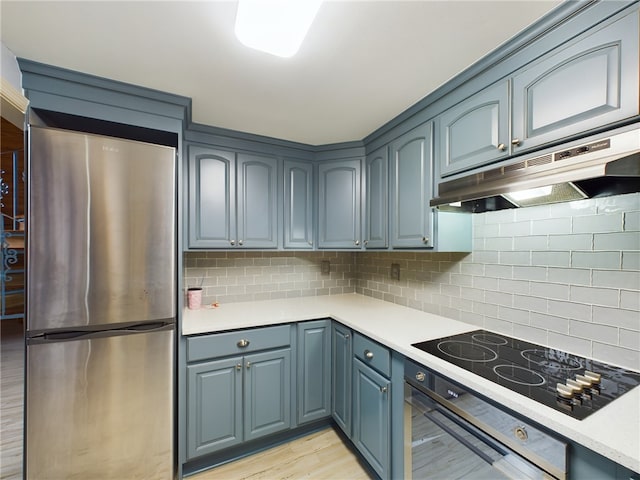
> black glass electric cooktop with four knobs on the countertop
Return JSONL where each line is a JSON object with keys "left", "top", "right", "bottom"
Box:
{"left": 413, "top": 330, "right": 640, "bottom": 420}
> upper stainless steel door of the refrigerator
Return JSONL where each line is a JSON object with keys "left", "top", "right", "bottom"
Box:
{"left": 27, "top": 127, "right": 176, "bottom": 332}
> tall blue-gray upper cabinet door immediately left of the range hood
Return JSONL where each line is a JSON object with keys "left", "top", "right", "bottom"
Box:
{"left": 389, "top": 122, "right": 433, "bottom": 248}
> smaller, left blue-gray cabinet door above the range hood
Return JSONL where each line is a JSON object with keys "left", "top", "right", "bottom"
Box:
{"left": 437, "top": 81, "right": 510, "bottom": 177}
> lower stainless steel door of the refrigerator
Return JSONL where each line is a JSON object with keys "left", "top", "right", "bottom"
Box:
{"left": 25, "top": 325, "right": 175, "bottom": 480}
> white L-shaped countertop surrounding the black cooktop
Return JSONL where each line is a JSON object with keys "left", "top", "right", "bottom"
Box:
{"left": 182, "top": 294, "right": 640, "bottom": 472}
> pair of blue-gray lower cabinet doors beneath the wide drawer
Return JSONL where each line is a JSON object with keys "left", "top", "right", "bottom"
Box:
{"left": 187, "top": 348, "right": 291, "bottom": 458}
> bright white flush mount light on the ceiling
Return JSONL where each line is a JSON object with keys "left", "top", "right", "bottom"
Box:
{"left": 235, "top": 0, "right": 322, "bottom": 58}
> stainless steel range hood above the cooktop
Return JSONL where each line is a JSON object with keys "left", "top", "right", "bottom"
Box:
{"left": 431, "top": 124, "right": 640, "bottom": 211}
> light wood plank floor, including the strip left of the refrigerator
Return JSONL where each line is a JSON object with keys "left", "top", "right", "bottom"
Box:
{"left": 0, "top": 320, "right": 371, "bottom": 480}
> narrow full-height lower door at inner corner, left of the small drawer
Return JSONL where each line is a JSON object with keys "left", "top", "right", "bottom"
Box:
{"left": 331, "top": 322, "right": 353, "bottom": 437}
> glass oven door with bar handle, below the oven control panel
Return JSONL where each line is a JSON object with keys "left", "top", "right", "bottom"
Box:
{"left": 405, "top": 383, "right": 553, "bottom": 480}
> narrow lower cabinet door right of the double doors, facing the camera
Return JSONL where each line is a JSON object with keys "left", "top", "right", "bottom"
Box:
{"left": 297, "top": 319, "right": 331, "bottom": 424}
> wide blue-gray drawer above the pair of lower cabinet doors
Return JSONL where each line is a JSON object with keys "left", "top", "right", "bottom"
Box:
{"left": 187, "top": 325, "right": 291, "bottom": 362}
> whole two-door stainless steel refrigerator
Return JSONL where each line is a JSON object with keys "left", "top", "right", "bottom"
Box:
{"left": 24, "top": 127, "right": 177, "bottom": 480}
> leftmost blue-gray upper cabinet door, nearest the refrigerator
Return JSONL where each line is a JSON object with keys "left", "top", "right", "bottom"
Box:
{"left": 189, "top": 147, "right": 236, "bottom": 248}
